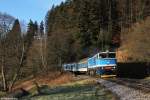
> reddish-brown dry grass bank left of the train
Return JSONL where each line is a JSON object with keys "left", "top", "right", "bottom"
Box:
{"left": 13, "top": 72, "right": 72, "bottom": 91}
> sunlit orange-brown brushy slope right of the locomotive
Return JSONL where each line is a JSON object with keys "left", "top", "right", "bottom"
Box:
{"left": 118, "top": 18, "right": 150, "bottom": 62}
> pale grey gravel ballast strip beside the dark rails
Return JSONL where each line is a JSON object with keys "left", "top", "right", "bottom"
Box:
{"left": 98, "top": 79, "right": 150, "bottom": 100}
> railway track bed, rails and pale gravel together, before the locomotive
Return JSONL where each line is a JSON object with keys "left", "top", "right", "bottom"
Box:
{"left": 97, "top": 78, "right": 150, "bottom": 100}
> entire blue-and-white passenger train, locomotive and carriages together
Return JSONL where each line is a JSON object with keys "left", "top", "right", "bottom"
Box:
{"left": 63, "top": 51, "right": 117, "bottom": 77}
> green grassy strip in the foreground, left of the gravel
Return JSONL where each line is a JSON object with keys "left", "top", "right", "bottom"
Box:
{"left": 21, "top": 79, "right": 116, "bottom": 100}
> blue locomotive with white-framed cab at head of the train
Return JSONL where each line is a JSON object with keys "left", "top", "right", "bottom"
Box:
{"left": 88, "top": 52, "right": 117, "bottom": 77}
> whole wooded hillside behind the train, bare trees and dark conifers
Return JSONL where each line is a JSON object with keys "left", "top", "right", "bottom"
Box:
{"left": 0, "top": 0, "right": 150, "bottom": 91}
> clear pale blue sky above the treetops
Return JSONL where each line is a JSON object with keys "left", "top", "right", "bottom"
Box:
{"left": 0, "top": 0, "right": 65, "bottom": 22}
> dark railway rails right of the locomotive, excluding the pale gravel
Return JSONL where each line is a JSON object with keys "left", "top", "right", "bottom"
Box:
{"left": 108, "top": 78, "right": 150, "bottom": 93}
